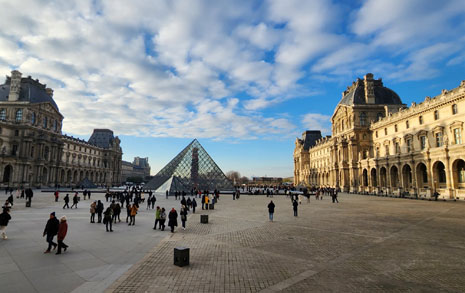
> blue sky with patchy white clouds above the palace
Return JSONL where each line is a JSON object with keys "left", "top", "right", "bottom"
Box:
{"left": 0, "top": 0, "right": 465, "bottom": 176}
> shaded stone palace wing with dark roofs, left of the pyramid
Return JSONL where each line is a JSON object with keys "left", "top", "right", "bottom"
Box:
{"left": 0, "top": 70, "right": 122, "bottom": 187}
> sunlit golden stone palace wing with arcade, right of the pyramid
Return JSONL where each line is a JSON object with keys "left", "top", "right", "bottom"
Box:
{"left": 294, "top": 73, "right": 465, "bottom": 198}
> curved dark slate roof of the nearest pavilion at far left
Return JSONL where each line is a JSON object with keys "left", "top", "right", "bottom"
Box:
{"left": 0, "top": 76, "right": 60, "bottom": 112}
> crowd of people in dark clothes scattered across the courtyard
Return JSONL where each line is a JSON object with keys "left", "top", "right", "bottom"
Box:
{"left": 0, "top": 187, "right": 338, "bottom": 254}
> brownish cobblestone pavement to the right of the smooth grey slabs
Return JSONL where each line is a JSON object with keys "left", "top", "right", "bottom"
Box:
{"left": 107, "top": 194, "right": 465, "bottom": 292}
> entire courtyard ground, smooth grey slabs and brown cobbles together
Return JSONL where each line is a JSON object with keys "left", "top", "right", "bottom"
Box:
{"left": 0, "top": 192, "right": 465, "bottom": 292}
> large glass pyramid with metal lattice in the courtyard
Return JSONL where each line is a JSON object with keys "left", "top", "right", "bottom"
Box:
{"left": 144, "top": 139, "right": 234, "bottom": 194}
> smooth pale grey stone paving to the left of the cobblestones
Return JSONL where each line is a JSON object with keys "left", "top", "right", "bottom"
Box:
{"left": 0, "top": 190, "right": 185, "bottom": 293}
